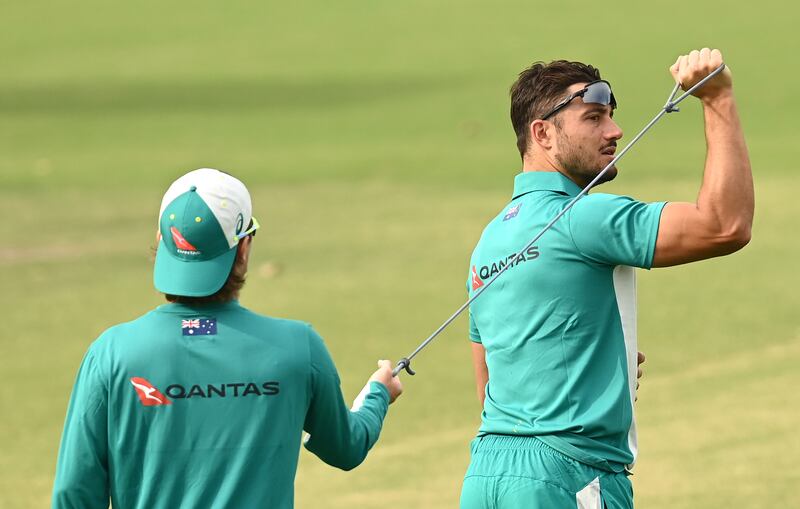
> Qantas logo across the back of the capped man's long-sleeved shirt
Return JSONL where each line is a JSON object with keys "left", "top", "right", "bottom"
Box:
{"left": 131, "top": 376, "right": 281, "bottom": 406}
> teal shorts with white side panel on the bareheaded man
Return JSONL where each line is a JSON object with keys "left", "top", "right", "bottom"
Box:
{"left": 461, "top": 435, "right": 633, "bottom": 509}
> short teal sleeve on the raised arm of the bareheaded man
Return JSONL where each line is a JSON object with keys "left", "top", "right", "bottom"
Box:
{"left": 569, "top": 193, "right": 666, "bottom": 269}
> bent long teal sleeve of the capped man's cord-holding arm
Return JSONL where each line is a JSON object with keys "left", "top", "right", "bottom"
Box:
{"left": 303, "top": 327, "right": 389, "bottom": 470}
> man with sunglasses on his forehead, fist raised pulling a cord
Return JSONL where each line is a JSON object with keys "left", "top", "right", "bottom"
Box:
{"left": 461, "top": 48, "right": 754, "bottom": 509}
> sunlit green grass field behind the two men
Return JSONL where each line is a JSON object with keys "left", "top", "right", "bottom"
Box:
{"left": 0, "top": 0, "right": 800, "bottom": 509}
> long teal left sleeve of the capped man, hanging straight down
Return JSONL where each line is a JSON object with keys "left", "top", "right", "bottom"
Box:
{"left": 52, "top": 348, "right": 109, "bottom": 509}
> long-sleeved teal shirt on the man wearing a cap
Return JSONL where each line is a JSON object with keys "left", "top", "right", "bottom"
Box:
{"left": 52, "top": 302, "right": 389, "bottom": 509}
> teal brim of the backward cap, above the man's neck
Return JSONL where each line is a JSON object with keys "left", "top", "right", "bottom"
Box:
{"left": 153, "top": 239, "right": 237, "bottom": 297}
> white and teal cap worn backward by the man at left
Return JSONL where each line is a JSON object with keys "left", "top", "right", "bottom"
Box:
{"left": 153, "top": 168, "right": 257, "bottom": 297}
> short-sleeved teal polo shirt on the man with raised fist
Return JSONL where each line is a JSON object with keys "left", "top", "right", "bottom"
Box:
{"left": 467, "top": 172, "right": 664, "bottom": 472}
